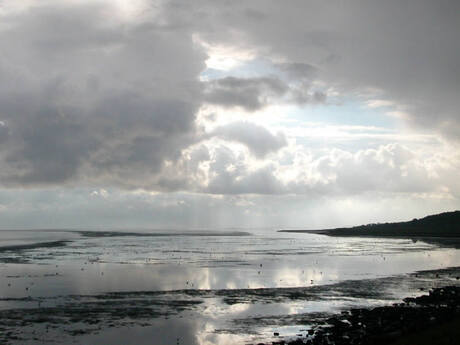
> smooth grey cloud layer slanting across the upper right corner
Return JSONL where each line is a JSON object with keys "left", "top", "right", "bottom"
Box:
{"left": 188, "top": 0, "right": 460, "bottom": 139}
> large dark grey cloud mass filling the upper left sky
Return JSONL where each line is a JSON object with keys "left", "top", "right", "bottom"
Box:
{"left": 0, "top": 2, "right": 205, "bottom": 189}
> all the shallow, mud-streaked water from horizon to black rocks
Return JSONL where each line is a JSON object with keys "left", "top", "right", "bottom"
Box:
{"left": 0, "top": 229, "right": 460, "bottom": 345}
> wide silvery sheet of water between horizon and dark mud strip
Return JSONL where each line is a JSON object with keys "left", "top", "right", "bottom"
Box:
{"left": 0, "top": 230, "right": 460, "bottom": 297}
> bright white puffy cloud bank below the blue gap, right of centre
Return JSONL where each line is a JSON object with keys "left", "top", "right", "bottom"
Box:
{"left": 195, "top": 144, "right": 459, "bottom": 199}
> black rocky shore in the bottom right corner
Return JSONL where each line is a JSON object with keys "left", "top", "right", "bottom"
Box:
{"left": 264, "top": 286, "right": 460, "bottom": 345}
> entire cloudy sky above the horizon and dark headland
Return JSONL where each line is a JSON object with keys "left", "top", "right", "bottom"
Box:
{"left": 0, "top": 0, "right": 460, "bottom": 229}
